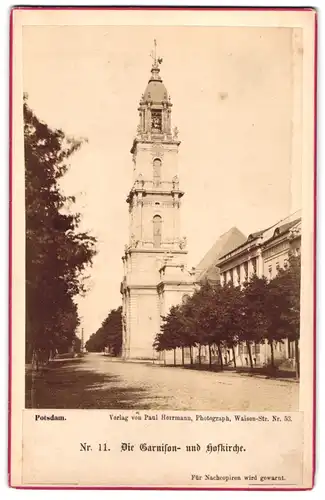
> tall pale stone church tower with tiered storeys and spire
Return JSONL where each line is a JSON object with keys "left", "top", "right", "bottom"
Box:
{"left": 121, "top": 41, "right": 193, "bottom": 359}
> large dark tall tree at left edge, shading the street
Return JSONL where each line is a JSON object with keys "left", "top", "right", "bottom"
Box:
{"left": 23, "top": 96, "right": 96, "bottom": 364}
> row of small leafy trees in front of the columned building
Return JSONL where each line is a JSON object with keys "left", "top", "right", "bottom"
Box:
{"left": 154, "top": 256, "right": 300, "bottom": 371}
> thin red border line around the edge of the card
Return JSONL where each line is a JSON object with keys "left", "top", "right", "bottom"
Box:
{"left": 8, "top": 6, "right": 318, "bottom": 491}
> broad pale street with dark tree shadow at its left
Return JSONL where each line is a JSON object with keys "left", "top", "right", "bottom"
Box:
{"left": 27, "top": 354, "right": 299, "bottom": 411}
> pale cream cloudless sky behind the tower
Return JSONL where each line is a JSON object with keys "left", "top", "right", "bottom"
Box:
{"left": 23, "top": 26, "right": 301, "bottom": 339}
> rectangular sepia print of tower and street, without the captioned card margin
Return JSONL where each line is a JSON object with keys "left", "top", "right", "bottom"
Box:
{"left": 22, "top": 25, "right": 304, "bottom": 411}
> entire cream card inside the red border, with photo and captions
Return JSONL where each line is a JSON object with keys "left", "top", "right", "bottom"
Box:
{"left": 12, "top": 9, "right": 315, "bottom": 487}
